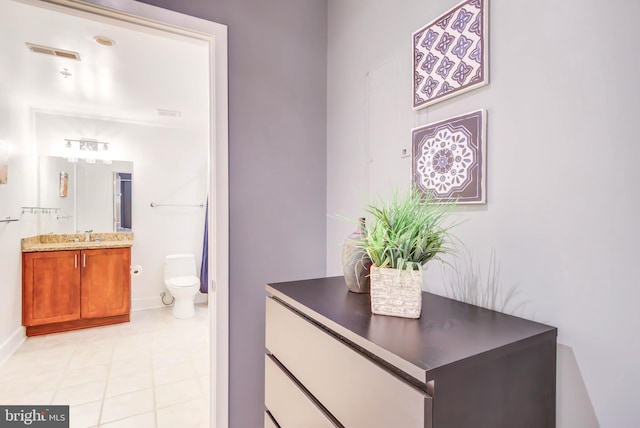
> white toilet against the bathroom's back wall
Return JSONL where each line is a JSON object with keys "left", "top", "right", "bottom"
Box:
{"left": 164, "top": 254, "right": 200, "bottom": 318}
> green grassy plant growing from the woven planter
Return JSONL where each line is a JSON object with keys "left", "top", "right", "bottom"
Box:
{"left": 360, "top": 187, "right": 455, "bottom": 270}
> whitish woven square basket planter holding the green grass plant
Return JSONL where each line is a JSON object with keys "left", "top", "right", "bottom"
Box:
{"left": 370, "top": 266, "right": 422, "bottom": 318}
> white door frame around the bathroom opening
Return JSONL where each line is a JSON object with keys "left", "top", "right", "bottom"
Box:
{"left": 28, "top": 0, "right": 229, "bottom": 427}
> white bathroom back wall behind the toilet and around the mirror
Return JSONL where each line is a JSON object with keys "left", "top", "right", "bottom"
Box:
{"left": 34, "top": 112, "right": 208, "bottom": 309}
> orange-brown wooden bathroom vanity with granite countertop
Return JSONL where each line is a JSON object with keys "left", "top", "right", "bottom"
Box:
{"left": 22, "top": 233, "right": 133, "bottom": 336}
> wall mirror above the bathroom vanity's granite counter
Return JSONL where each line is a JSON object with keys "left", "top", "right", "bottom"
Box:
{"left": 38, "top": 156, "right": 133, "bottom": 233}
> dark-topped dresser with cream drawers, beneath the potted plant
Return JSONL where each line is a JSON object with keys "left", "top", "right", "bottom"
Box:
{"left": 265, "top": 277, "right": 557, "bottom": 428}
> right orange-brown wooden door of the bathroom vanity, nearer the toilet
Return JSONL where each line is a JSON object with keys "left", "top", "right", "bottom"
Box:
{"left": 81, "top": 248, "right": 131, "bottom": 318}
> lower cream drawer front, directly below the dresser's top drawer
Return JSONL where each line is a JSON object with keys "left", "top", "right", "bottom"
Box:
{"left": 264, "top": 355, "right": 336, "bottom": 428}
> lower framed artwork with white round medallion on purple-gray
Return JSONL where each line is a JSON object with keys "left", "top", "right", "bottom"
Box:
{"left": 411, "top": 110, "right": 486, "bottom": 204}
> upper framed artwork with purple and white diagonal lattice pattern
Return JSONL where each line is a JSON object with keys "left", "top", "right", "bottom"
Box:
{"left": 413, "top": 0, "right": 489, "bottom": 110}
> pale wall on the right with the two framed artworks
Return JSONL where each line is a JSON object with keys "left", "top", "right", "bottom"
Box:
{"left": 327, "top": 0, "right": 640, "bottom": 428}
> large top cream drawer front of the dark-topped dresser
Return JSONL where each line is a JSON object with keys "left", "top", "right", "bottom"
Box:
{"left": 266, "top": 298, "right": 432, "bottom": 428}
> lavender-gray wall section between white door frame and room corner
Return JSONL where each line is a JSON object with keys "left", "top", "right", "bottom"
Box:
{"left": 144, "top": 0, "right": 327, "bottom": 428}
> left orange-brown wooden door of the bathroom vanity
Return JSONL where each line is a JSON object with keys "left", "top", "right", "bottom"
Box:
{"left": 22, "top": 251, "right": 80, "bottom": 326}
